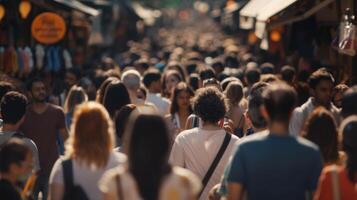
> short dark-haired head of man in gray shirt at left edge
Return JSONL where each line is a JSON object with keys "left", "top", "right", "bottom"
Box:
{"left": 0, "top": 91, "right": 27, "bottom": 125}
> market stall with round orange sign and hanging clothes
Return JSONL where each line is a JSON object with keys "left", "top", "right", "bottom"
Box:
{"left": 0, "top": 0, "right": 99, "bottom": 79}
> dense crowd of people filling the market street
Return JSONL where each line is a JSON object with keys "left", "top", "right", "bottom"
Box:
{"left": 0, "top": 12, "right": 357, "bottom": 200}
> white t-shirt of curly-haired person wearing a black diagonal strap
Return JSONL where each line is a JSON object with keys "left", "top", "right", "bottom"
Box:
{"left": 170, "top": 128, "right": 239, "bottom": 200}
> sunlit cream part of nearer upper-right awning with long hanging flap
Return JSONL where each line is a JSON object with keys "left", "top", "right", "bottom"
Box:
{"left": 255, "top": 0, "right": 297, "bottom": 38}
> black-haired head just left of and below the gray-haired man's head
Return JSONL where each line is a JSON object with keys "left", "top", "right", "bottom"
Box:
{"left": 103, "top": 80, "right": 131, "bottom": 118}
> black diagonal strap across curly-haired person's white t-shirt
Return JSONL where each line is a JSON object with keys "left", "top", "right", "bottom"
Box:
{"left": 199, "top": 133, "right": 232, "bottom": 196}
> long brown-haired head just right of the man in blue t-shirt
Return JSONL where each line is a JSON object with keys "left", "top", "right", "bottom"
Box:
{"left": 304, "top": 106, "right": 338, "bottom": 163}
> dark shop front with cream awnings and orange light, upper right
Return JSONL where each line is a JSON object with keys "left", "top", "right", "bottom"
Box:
{"left": 236, "top": 0, "right": 357, "bottom": 83}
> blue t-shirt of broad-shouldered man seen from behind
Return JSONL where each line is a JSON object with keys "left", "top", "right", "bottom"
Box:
{"left": 227, "top": 134, "right": 322, "bottom": 200}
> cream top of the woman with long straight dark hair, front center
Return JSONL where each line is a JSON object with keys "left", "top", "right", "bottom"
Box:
{"left": 99, "top": 166, "right": 201, "bottom": 200}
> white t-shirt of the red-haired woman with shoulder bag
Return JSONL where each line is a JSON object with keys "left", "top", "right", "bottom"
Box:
{"left": 49, "top": 151, "right": 126, "bottom": 200}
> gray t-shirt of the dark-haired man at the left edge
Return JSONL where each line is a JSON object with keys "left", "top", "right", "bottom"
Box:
{"left": 0, "top": 131, "right": 40, "bottom": 172}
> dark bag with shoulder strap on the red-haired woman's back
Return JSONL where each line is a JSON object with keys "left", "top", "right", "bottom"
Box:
{"left": 62, "top": 159, "right": 89, "bottom": 200}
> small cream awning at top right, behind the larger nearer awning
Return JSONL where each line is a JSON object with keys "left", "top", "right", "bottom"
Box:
{"left": 239, "top": 0, "right": 275, "bottom": 30}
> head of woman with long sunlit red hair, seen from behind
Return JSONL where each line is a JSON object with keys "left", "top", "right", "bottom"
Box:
{"left": 66, "top": 102, "right": 115, "bottom": 168}
